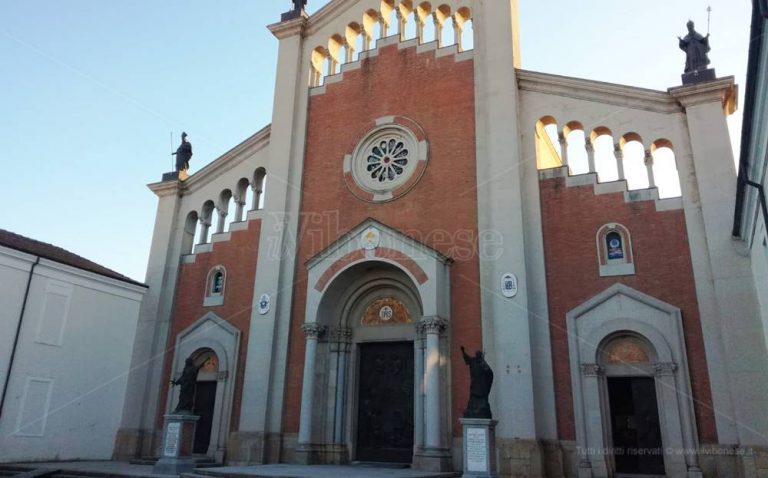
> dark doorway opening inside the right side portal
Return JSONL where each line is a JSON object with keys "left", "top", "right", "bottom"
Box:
{"left": 608, "top": 377, "right": 665, "bottom": 475}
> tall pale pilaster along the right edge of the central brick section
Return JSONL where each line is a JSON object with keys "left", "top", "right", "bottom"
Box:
{"left": 474, "top": 0, "right": 539, "bottom": 448}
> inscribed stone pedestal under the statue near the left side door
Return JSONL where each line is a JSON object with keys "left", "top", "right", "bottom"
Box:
{"left": 152, "top": 414, "right": 200, "bottom": 475}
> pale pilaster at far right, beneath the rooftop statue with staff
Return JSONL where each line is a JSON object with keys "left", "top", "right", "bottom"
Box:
{"left": 669, "top": 78, "right": 768, "bottom": 445}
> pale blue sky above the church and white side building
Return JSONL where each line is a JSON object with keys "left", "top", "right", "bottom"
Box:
{"left": 0, "top": 0, "right": 751, "bottom": 280}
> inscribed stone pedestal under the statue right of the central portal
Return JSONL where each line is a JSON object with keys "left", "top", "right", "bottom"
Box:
{"left": 459, "top": 418, "right": 498, "bottom": 478}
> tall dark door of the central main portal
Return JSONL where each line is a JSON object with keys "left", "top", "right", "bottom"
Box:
{"left": 357, "top": 342, "right": 413, "bottom": 463}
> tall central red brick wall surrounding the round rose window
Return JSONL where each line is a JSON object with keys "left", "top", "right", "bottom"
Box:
{"left": 284, "top": 45, "right": 482, "bottom": 435}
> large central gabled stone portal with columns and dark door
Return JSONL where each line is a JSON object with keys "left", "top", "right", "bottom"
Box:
{"left": 297, "top": 220, "right": 451, "bottom": 469}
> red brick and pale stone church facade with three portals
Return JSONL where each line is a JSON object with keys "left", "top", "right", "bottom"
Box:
{"left": 114, "top": 0, "right": 768, "bottom": 478}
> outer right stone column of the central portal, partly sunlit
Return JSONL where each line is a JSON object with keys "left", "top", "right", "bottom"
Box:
{"left": 414, "top": 317, "right": 451, "bottom": 472}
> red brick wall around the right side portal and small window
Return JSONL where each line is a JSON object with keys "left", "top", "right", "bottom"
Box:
{"left": 540, "top": 178, "right": 717, "bottom": 443}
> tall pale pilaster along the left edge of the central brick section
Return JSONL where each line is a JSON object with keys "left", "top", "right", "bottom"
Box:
{"left": 233, "top": 14, "right": 316, "bottom": 464}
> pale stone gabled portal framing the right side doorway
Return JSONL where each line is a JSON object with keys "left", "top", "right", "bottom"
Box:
{"left": 567, "top": 284, "right": 702, "bottom": 478}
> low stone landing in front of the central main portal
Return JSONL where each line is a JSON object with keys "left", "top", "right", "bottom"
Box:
{"left": 197, "top": 465, "right": 461, "bottom": 478}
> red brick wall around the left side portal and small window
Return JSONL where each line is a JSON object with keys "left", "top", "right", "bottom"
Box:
{"left": 157, "top": 219, "right": 261, "bottom": 431}
